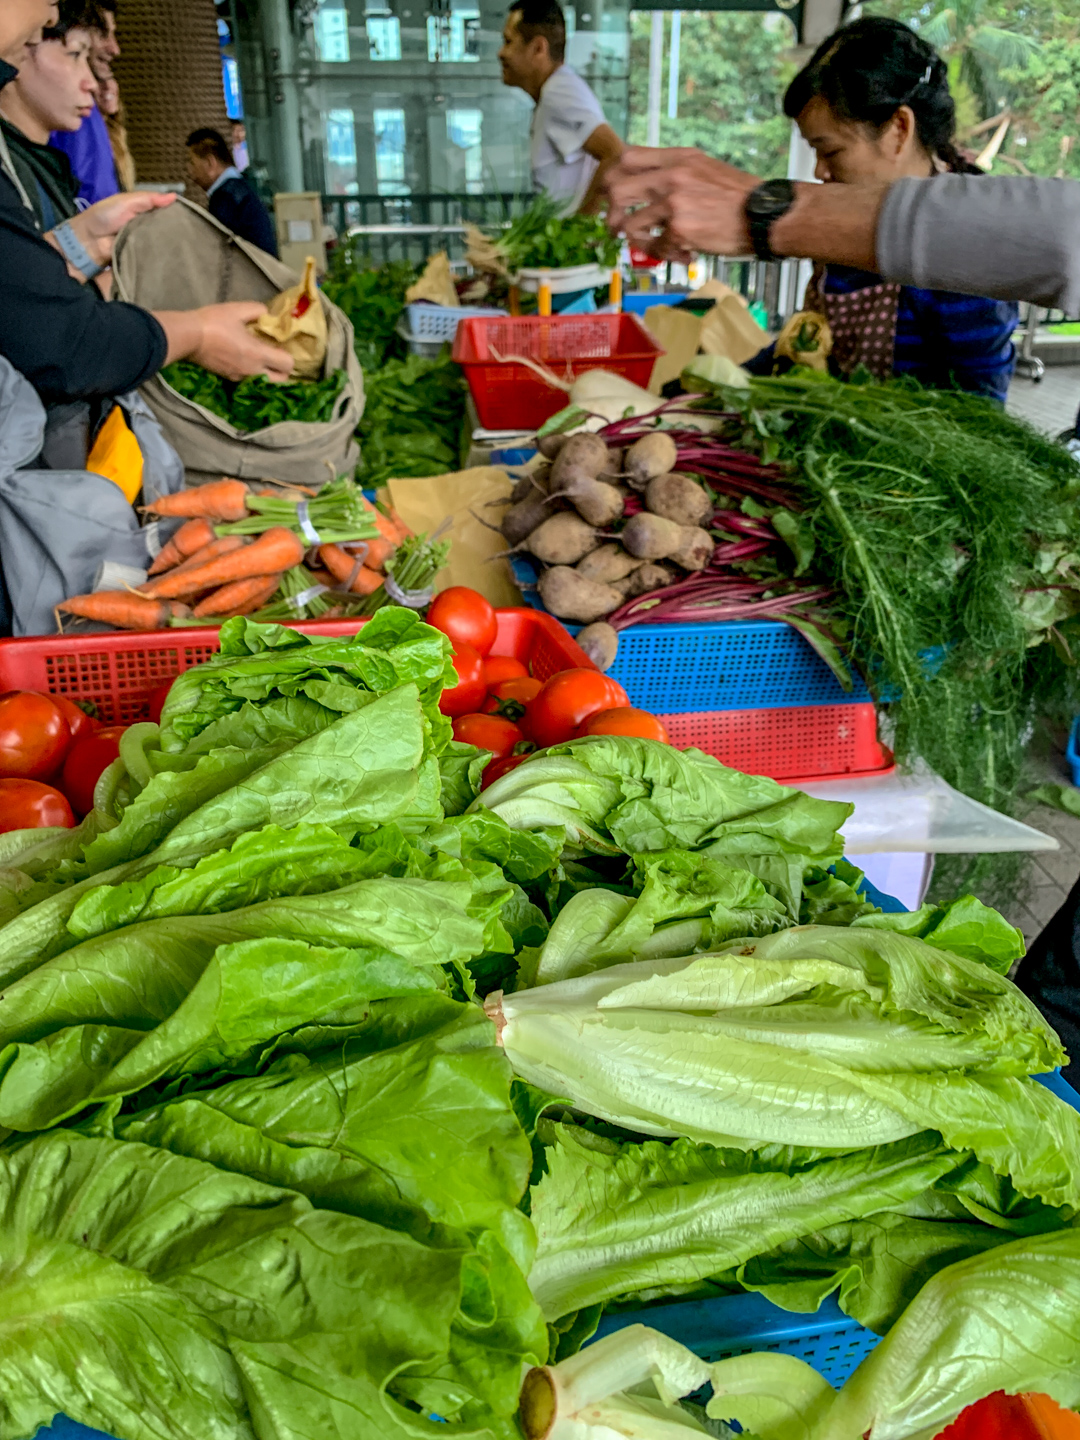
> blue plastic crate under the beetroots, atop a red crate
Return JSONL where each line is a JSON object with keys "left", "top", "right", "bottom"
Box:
{"left": 511, "top": 554, "right": 874, "bottom": 714}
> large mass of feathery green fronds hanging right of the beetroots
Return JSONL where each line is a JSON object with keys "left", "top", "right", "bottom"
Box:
{"left": 714, "top": 370, "right": 1080, "bottom": 811}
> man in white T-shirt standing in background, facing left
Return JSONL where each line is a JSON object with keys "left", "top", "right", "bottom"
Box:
{"left": 498, "top": 0, "right": 624, "bottom": 215}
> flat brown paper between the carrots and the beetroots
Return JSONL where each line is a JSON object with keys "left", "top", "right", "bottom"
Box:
{"left": 386, "top": 465, "right": 521, "bottom": 605}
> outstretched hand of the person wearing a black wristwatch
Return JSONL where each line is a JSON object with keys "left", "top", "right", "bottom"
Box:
{"left": 605, "top": 145, "right": 760, "bottom": 262}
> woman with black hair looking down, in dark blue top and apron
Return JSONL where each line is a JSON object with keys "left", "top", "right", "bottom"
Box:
{"left": 749, "top": 17, "right": 1017, "bottom": 402}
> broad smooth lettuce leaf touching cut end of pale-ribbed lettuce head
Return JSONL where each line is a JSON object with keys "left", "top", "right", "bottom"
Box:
{"left": 114, "top": 994, "right": 533, "bottom": 1270}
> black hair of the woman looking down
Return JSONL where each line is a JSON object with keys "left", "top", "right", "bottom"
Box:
{"left": 783, "top": 16, "right": 981, "bottom": 174}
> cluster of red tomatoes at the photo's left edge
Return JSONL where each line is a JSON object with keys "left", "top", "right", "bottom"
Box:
{"left": 0, "top": 690, "right": 136, "bottom": 834}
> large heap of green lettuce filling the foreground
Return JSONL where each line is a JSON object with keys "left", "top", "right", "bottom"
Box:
{"left": 0, "top": 616, "right": 1080, "bottom": 1440}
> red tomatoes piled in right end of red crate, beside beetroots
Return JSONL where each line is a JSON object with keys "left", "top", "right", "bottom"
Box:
{"left": 428, "top": 585, "right": 668, "bottom": 786}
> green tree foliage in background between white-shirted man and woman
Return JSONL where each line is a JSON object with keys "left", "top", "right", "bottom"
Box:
{"left": 629, "top": 10, "right": 795, "bottom": 177}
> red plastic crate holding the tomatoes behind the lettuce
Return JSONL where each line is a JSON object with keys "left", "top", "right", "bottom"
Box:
{"left": 0, "top": 608, "right": 596, "bottom": 724}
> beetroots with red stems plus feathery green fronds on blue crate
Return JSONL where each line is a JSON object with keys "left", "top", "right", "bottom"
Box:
{"left": 515, "top": 370, "right": 1080, "bottom": 835}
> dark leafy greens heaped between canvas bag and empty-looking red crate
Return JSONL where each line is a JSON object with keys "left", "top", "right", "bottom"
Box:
{"left": 357, "top": 347, "right": 465, "bottom": 487}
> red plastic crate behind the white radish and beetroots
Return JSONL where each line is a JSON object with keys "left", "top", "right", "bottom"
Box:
{"left": 454, "top": 314, "right": 664, "bottom": 431}
